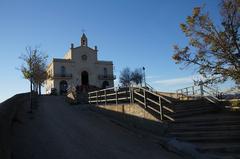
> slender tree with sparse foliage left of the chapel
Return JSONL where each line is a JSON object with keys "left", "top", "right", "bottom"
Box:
{"left": 19, "top": 46, "right": 48, "bottom": 93}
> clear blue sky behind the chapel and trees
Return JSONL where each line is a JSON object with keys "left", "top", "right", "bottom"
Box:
{"left": 0, "top": 0, "right": 229, "bottom": 102}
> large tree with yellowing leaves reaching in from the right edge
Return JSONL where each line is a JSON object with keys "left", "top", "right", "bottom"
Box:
{"left": 173, "top": 0, "right": 240, "bottom": 84}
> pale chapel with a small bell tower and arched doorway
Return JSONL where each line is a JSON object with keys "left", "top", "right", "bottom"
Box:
{"left": 45, "top": 33, "right": 116, "bottom": 94}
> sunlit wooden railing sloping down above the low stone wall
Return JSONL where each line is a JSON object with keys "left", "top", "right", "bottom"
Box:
{"left": 88, "top": 87, "right": 174, "bottom": 121}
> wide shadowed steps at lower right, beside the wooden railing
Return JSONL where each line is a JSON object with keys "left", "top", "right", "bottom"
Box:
{"left": 167, "top": 99, "right": 240, "bottom": 158}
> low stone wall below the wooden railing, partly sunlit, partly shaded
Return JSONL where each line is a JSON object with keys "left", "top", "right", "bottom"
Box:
{"left": 95, "top": 104, "right": 168, "bottom": 136}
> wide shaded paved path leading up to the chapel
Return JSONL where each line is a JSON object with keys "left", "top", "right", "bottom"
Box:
{"left": 12, "top": 96, "right": 182, "bottom": 159}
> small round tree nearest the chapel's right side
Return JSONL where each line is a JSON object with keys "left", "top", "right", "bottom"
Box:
{"left": 119, "top": 67, "right": 131, "bottom": 87}
